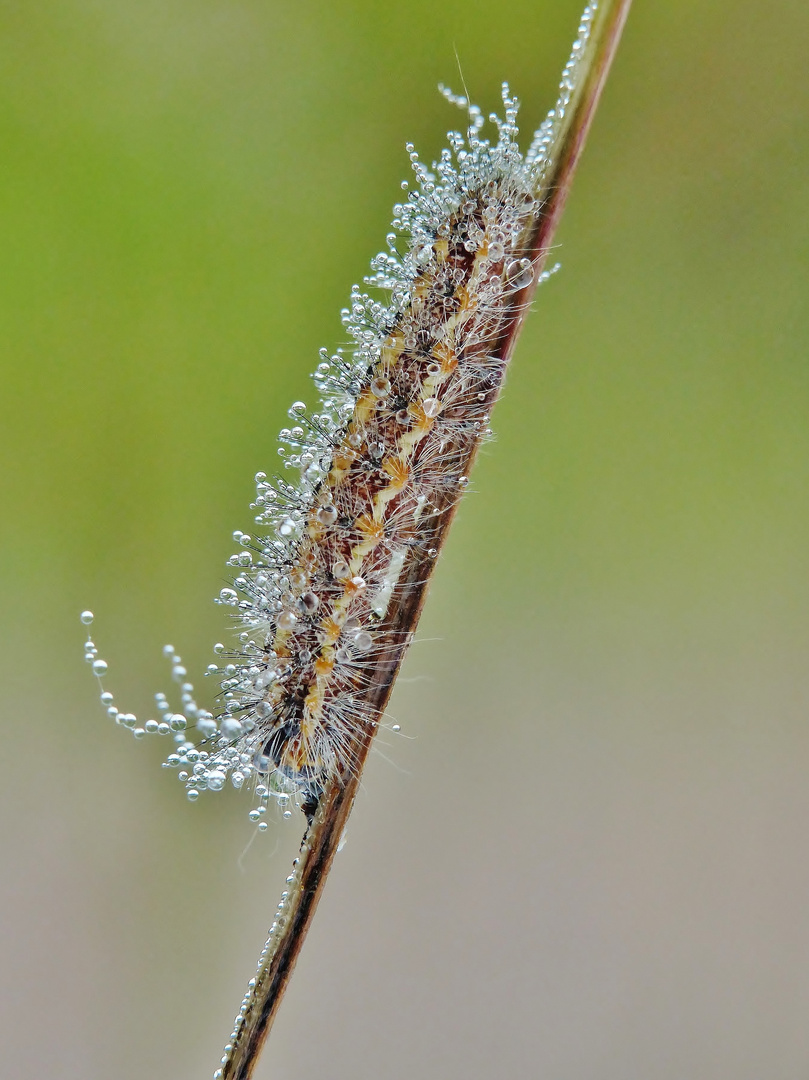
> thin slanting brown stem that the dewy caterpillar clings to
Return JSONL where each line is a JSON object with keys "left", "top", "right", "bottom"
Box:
{"left": 217, "top": 0, "right": 631, "bottom": 1080}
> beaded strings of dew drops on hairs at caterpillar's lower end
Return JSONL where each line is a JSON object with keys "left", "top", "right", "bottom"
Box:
{"left": 80, "top": 611, "right": 294, "bottom": 833}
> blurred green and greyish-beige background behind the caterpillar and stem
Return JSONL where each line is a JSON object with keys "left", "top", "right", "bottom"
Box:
{"left": 0, "top": 0, "right": 809, "bottom": 1080}
